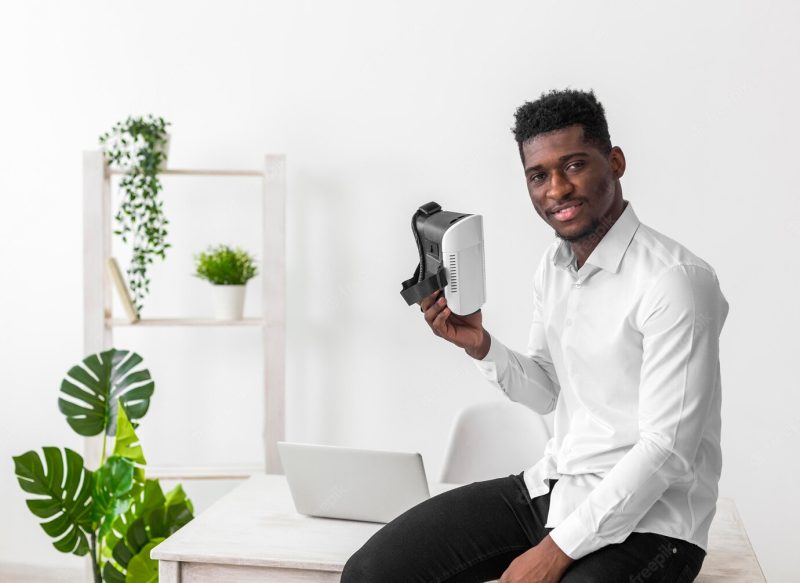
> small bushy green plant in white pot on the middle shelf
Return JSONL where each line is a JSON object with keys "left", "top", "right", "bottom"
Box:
{"left": 194, "top": 245, "right": 257, "bottom": 320}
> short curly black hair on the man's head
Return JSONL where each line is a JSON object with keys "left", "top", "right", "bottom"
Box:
{"left": 511, "top": 89, "right": 611, "bottom": 161}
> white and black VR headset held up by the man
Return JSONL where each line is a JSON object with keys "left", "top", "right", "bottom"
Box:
{"left": 400, "top": 202, "right": 486, "bottom": 316}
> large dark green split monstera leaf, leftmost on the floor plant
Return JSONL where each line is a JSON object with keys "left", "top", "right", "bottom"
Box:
{"left": 14, "top": 447, "right": 93, "bottom": 555}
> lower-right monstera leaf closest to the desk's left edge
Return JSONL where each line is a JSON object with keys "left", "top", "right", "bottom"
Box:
{"left": 103, "top": 486, "right": 193, "bottom": 583}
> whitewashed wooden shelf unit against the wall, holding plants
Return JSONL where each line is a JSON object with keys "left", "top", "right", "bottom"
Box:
{"left": 83, "top": 150, "right": 286, "bottom": 479}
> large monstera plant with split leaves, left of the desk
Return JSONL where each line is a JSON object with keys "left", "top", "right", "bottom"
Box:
{"left": 14, "top": 348, "right": 194, "bottom": 583}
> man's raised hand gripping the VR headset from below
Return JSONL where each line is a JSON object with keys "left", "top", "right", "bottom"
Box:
{"left": 419, "top": 290, "right": 491, "bottom": 360}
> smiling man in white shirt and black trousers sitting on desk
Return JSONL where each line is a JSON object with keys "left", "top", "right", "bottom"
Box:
{"left": 342, "top": 90, "right": 728, "bottom": 583}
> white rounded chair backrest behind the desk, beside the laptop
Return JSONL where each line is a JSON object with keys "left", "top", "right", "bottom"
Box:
{"left": 440, "top": 400, "right": 551, "bottom": 484}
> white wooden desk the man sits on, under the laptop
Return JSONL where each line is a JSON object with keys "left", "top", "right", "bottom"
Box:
{"left": 150, "top": 474, "right": 765, "bottom": 583}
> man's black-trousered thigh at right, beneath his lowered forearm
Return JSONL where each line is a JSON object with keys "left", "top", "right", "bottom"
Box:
{"left": 561, "top": 532, "right": 705, "bottom": 583}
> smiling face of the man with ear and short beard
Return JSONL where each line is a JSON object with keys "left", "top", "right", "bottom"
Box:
{"left": 522, "top": 125, "right": 625, "bottom": 241}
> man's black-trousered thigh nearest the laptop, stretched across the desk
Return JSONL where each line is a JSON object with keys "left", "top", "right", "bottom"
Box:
{"left": 341, "top": 474, "right": 549, "bottom": 583}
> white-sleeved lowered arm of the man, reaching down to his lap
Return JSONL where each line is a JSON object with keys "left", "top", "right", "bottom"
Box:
{"left": 550, "top": 265, "right": 728, "bottom": 559}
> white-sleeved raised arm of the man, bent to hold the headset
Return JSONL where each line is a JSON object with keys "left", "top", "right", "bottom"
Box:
{"left": 467, "top": 254, "right": 561, "bottom": 415}
